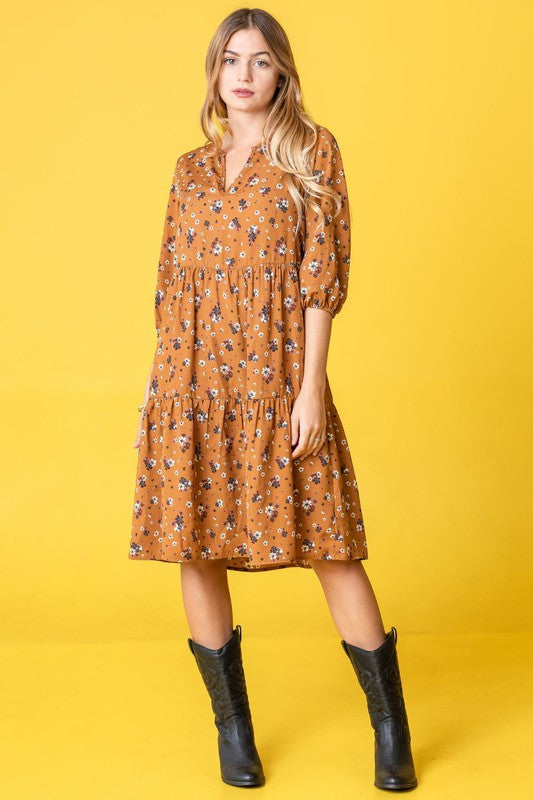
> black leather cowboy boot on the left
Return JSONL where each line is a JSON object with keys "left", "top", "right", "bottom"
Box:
{"left": 187, "top": 625, "right": 265, "bottom": 786}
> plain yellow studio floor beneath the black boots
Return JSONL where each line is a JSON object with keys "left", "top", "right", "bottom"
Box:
{"left": 0, "top": 631, "right": 533, "bottom": 800}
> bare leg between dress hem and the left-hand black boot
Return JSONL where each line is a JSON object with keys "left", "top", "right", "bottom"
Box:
{"left": 181, "top": 559, "right": 233, "bottom": 650}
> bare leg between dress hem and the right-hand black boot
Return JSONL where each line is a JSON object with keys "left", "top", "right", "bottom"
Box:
{"left": 310, "top": 559, "right": 385, "bottom": 650}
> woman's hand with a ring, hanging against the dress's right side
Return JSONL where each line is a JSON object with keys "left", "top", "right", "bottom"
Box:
{"left": 291, "top": 384, "right": 326, "bottom": 459}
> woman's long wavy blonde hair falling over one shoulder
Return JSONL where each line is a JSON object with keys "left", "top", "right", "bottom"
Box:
{"left": 200, "top": 8, "right": 341, "bottom": 230}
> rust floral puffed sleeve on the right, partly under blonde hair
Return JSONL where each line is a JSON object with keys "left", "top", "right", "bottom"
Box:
{"left": 300, "top": 126, "right": 350, "bottom": 317}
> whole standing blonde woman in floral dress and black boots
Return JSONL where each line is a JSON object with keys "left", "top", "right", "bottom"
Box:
{"left": 130, "top": 9, "right": 417, "bottom": 789}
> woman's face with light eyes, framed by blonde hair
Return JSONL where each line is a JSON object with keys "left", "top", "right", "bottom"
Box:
{"left": 218, "top": 28, "right": 279, "bottom": 119}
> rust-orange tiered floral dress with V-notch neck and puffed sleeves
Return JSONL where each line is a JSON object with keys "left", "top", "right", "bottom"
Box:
{"left": 129, "top": 126, "right": 368, "bottom": 572}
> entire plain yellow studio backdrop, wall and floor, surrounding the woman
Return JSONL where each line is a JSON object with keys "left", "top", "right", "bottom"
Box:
{"left": 0, "top": 0, "right": 533, "bottom": 800}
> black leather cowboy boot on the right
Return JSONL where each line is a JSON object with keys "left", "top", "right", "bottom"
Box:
{"left": 341, "top": 626, "right": 418, "bottom": 789}
